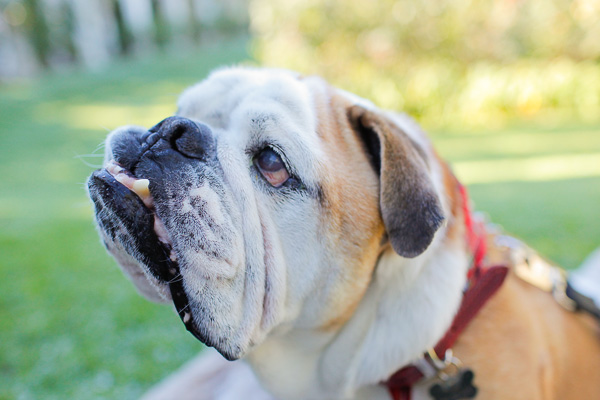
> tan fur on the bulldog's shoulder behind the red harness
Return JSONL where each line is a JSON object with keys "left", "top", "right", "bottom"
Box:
{"left": 454, "top": 273, "right": 600, "bottom": 400}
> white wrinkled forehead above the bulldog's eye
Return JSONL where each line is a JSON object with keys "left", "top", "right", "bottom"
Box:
{"left": 178, "top": 68, "right": 322, "bottom": 179}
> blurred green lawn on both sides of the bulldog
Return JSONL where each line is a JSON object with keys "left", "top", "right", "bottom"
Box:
{"left": 0, "top": 36, "right": 600, "bottom": 399}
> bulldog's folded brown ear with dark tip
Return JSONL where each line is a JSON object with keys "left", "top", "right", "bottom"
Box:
{"left": 348, "top": 106, "right": 444, "bottom": 258}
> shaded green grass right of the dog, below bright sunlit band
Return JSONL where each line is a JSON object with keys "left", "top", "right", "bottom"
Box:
{"left": 469, "top": 177, "right": 600, "bottom": 268}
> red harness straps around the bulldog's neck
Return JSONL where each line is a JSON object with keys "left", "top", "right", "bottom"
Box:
{"left": 383, "top": 185, "right": 508, "bottom": 400}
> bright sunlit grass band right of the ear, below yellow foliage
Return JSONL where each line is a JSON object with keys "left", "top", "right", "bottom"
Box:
{"left": 432, "top": 126, "right": 600, "bottom": 184}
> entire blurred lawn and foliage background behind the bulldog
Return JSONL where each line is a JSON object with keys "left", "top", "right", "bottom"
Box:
{"left": 0, "top": 0, "right": 600, "bottom": 400}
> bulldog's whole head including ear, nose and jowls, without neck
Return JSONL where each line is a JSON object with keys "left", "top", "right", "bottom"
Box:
{"left": 88, "top": 69, "right": 443, "bottom": 359}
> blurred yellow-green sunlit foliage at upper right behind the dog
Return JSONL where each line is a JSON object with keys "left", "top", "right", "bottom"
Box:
{"left": 250, "top": 0, "right": 600, "bottom": 126}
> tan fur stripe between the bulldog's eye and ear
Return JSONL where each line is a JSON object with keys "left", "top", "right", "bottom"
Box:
{"left": 314, "top": 83, "right": 385, "bottom": 331}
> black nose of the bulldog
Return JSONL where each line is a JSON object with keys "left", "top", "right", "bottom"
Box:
{"left": 144, "top": 117, "right": 215, "bottom": 161}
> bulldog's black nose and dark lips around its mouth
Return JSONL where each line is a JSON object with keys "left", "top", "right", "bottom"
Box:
{"left": 88, "top": 117, "right": 216, "bottom": 343}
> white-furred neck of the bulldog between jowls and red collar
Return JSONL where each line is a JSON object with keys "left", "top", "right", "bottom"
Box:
{"left": 249, "top": 230, "right": 469, "bottom": 399}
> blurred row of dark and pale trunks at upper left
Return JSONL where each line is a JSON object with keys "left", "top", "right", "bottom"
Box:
{"left": 0, "top": 0, "right": 248, "bottom": 82}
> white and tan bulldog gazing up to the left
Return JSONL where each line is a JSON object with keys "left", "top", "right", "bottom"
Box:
{"left": 88, "top": 68, "right": 600, "bottom": 400}
